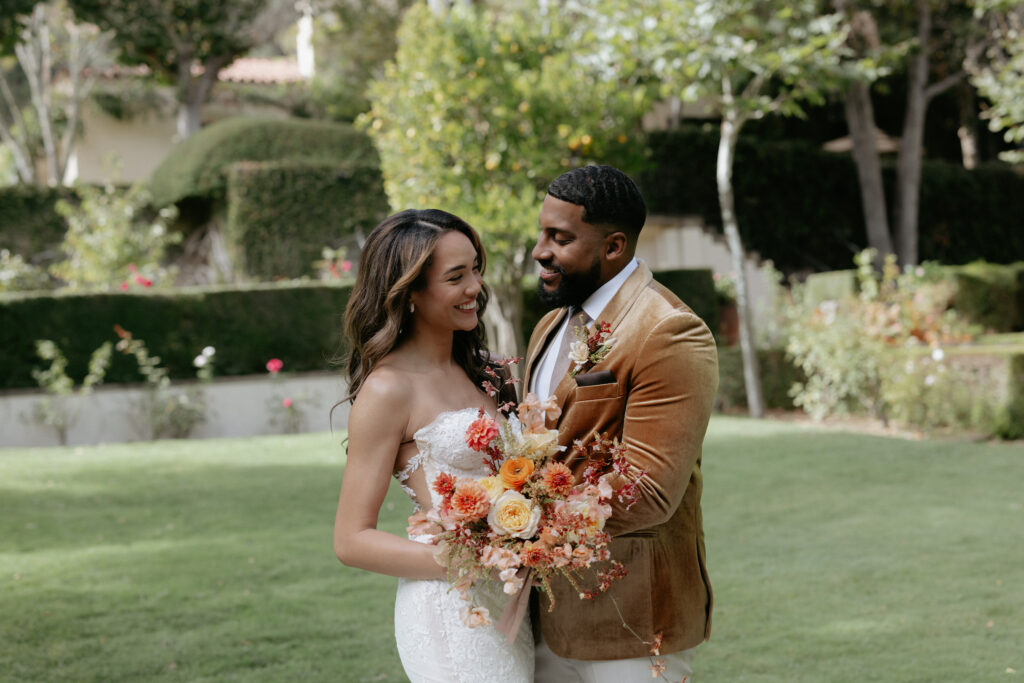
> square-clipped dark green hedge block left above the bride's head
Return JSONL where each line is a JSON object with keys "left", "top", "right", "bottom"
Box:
{"left": 224, "top": 161, "right": 387, "bottom": 280}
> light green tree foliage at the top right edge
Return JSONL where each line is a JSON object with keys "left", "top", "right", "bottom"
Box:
{"left": 967, "top": 0, "right": 1024, "bottom": 163}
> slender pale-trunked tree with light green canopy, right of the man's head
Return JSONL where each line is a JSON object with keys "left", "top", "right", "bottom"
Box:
{"left": 605, "top": 0, "right": 845, "bottom": 417}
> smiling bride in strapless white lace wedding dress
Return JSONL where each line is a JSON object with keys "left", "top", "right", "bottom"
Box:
{"left": 334, "top": 209, "right": 534, "bottom": 683}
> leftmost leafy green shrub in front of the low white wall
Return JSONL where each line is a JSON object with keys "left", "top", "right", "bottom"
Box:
{"left": 32, "top": 339, "right": 112, "bottom": 445}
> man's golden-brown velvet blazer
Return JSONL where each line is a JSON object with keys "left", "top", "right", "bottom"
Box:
{"left": 524, "top": 263, "right": 718, "bottom": 659}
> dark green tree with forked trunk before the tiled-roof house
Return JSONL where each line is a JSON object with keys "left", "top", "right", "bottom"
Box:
{"left": 69, "top": 0, "right": 297, "bottom": 139}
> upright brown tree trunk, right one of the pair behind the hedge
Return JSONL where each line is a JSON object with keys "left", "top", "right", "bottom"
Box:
{"left": 896, "top": 0, "right": 932, "bottom": 265}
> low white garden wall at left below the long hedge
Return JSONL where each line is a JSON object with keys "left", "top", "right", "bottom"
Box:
{"left": 0, "top": 373, "right": 349, "bottom": 446}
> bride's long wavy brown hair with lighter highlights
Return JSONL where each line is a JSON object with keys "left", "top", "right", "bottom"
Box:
{"left": 342, "top": 209, "right": 488, "bottom": 402}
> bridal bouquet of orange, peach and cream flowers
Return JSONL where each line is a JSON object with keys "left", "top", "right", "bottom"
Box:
{"left": 409, "top": 394, "right": 643, "bottom": 626}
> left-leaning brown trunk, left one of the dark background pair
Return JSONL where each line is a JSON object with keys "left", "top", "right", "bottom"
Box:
{"left": 846, "top": 81, "right": 895, "bottom": 269}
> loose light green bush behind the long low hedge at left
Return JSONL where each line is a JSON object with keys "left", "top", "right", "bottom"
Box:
{"left": 50, "top": 183, "right": 181, "bottom": 290}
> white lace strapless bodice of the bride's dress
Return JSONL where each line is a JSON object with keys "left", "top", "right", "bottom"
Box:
{"left": 394, "top": 408, "right": 490, "bottom": 510}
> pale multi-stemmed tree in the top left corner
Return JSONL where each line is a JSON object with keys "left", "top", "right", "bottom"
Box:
{"left": 0, "top": 1, "right": 111, "bottom": 185}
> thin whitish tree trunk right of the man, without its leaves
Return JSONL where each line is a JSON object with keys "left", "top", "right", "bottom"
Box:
{"left": 716, "top": 108, "right": 765, "bottom": 418}
